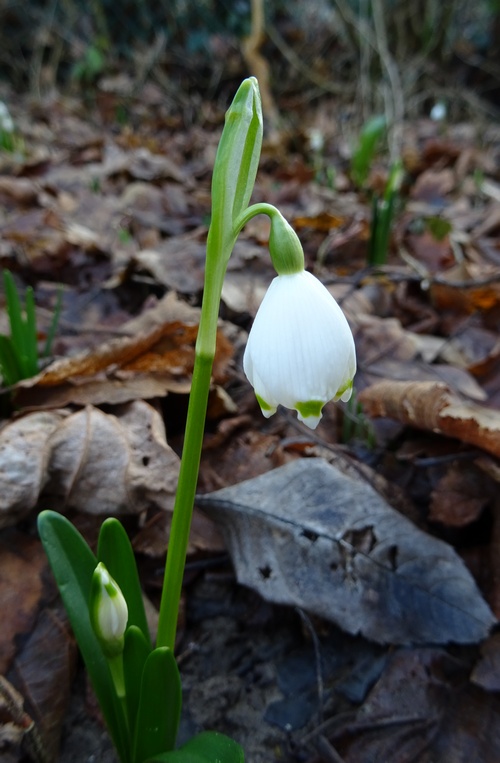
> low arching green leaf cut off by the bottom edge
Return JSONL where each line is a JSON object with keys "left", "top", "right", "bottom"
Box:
{"left": 145, "top": 731, "right": 245, "bottom": 763}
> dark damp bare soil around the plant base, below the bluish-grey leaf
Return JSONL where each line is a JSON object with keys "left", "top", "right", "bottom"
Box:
{"left": 60, "top": 572, "right": 385, "bottom": 763}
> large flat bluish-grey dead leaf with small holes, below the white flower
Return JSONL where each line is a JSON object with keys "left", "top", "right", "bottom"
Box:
{"left": 198, "top": 459, "right": 494, "bottom": 644}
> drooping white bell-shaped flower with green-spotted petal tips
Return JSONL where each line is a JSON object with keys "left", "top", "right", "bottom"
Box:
{"left": 243, "top": 270, "right": 356, "bottom": 429}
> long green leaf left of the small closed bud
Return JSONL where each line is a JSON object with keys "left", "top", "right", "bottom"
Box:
{"left": 38, "top": 511, "right": 131, "bottom": 763}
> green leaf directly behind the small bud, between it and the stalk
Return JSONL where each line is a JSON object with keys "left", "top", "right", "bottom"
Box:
{"left": 97, "top": 517, "right": 152, "bottom": 650}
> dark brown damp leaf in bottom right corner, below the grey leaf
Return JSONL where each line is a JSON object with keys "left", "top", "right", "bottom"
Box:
{"left": 330, "top": 648, "right": 500, "bottom": 763}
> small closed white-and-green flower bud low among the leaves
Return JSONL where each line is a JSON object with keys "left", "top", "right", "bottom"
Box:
{"left": 89, "top": 562, "right": 128, "bottom": 657}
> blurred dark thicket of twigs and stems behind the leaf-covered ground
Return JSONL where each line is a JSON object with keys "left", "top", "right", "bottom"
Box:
{"left": 0, "top": 0, "right": 500, "bottom": 126}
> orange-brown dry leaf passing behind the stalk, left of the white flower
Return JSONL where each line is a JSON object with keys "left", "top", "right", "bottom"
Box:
{"left": 16, "top": 292, "right": 233, "bottom": 409}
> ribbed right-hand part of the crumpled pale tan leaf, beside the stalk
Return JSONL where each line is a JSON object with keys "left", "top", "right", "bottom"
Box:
{"left": 43, "top": 400, "right": 179, "bottom": 514}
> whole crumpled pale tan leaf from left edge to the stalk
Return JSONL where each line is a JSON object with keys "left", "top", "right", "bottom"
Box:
{"left": 0, "top": 400, "right": 178, "bottom": 527}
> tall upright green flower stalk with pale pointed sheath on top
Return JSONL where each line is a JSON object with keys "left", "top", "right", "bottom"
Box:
{"left": 156, "top": 77, "right": 262, "bottom": 649}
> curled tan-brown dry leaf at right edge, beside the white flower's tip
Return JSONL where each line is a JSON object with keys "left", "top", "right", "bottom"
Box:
{"left": 359, "top": 381, "right": 500, "bottom": 456}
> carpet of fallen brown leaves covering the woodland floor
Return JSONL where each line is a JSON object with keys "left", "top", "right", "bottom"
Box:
{"left": 0, "top": 79, "right": 500, "bottom": 763}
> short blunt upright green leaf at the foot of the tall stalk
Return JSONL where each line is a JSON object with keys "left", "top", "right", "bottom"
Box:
{"left": 133, "top": 646, "right": 182, "bottom": 763}
